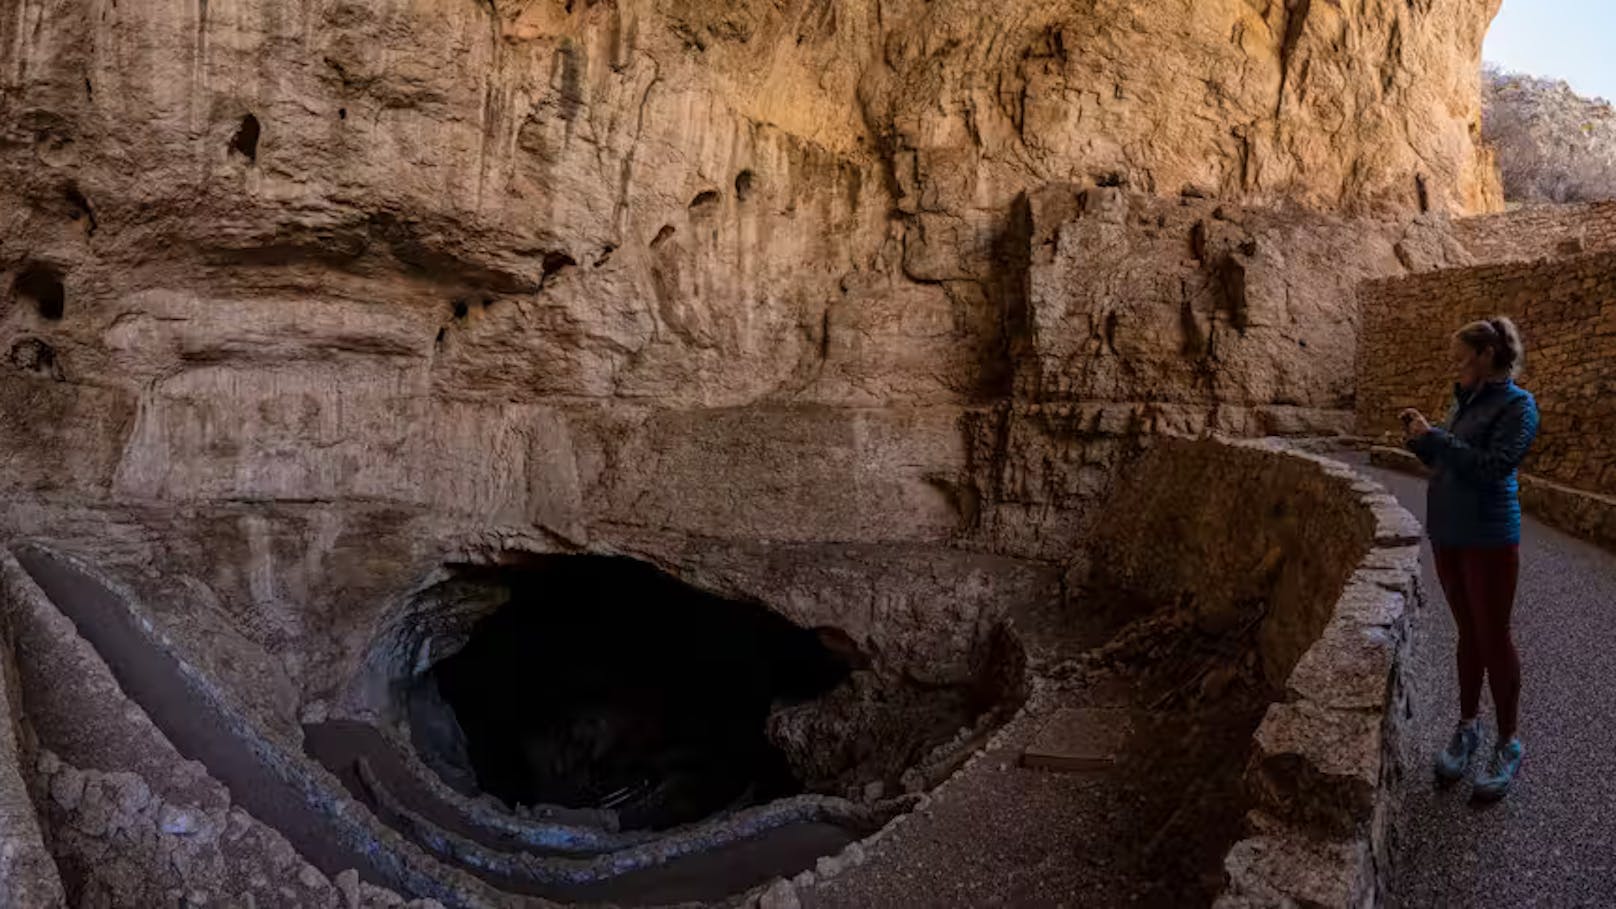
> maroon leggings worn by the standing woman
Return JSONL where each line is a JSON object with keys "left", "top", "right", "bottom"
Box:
{"left": 1435, "top": 547, "right": 1521, "bottom": 742}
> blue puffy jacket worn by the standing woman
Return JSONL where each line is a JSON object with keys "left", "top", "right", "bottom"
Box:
{"left": 1408, "top": 378, "right": 1538, "bottom": 547}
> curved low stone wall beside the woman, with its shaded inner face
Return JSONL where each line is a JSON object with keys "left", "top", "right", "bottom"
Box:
{"left": 1021, "top": 438, "right": 1422, "bottom": 909}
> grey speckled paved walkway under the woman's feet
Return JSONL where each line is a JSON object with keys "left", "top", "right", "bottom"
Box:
{"left": 1370, "top": 471, "right": 1616, "bottom": 909}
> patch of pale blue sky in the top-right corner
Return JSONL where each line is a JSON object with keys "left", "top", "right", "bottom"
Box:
{"left": 1482, "top": 0, "right": 1616, "bottom": 102}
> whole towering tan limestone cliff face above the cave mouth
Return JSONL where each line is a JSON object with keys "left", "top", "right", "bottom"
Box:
{"left": 0, "top": 0, "right": 1498, "bottom": 684}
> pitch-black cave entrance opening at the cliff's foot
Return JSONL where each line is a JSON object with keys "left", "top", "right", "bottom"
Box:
{"left": 409, "top": 556, "right": 852, "bottom": 830}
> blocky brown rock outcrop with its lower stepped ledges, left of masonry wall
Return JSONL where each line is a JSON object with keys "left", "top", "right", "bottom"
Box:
{"left": 947, "top": 184, "right": 1467, "bottom": 561}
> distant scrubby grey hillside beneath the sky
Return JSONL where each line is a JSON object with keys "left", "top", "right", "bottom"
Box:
{"left": 1482, "top": 65, "right": 1616, "bottom": 202}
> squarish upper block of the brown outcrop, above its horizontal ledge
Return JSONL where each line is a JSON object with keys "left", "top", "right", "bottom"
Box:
{"left": 1015, "top": 186, "right": 1404, "bottom": 420}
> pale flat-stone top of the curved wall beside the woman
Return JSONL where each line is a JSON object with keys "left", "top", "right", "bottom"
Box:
{"left": 1195, "top": 442, "right": 1424, "bottom": 909}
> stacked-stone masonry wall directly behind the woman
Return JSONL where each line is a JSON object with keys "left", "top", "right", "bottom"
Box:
{"left": 1357, "top": 252, "right": 1616, "bottom": 495}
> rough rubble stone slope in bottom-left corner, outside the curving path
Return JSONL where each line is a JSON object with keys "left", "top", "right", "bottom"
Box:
{"left": 0, "top": 548, "right": 462, "bottom": 909}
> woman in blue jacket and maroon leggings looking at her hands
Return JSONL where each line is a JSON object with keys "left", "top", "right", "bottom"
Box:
{"left": 1403, "top": 317, "right": 1538, "bottom": 799}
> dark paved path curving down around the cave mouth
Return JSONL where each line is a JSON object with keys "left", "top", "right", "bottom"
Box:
{"left": 12, "top": 547, "right": 886, "bottom": 909}
